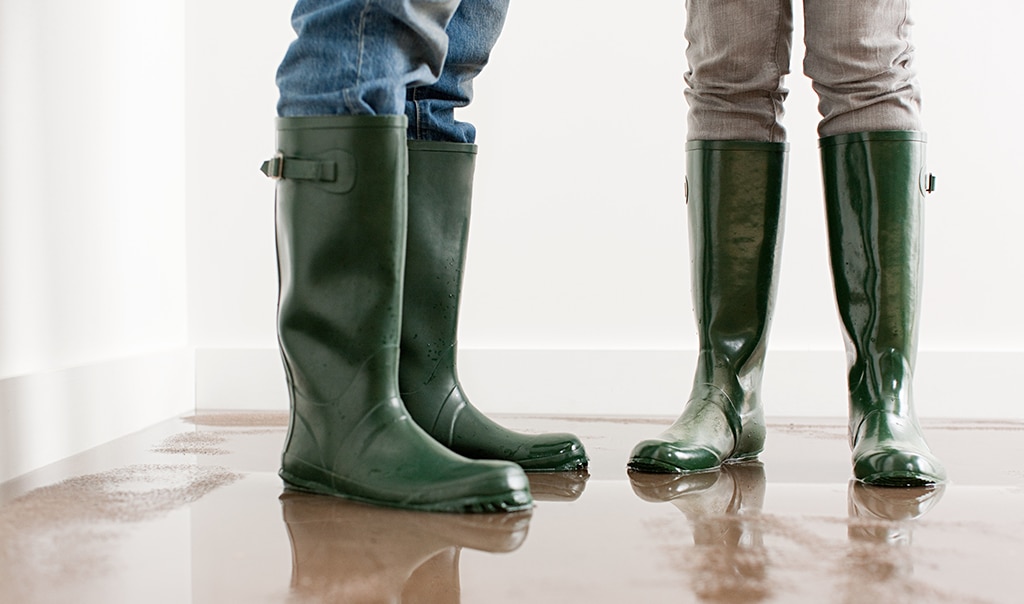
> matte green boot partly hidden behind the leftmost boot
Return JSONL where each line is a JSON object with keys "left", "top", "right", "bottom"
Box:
{"left": 398, "top": 141, "right": 587, "bottom": 472}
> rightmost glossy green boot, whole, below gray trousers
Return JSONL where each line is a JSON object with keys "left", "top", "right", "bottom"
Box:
{"left": 821, "top": 131, "right": 946, "bottom": 486}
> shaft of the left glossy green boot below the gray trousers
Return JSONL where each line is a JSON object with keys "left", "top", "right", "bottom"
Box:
{"left": 686, "top": 141, "right": 786, "bottom": 383}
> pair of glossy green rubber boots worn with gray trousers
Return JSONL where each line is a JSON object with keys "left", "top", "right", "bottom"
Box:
{"left": 629, "top": 131, "right": 945, "bottom": 486}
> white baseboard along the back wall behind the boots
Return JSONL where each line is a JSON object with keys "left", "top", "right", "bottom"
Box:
{"left": 196, "top": 348, "right": 1024, "bottom": 419}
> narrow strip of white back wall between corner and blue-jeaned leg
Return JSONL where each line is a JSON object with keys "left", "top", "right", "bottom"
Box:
{"left": 184, "top": 0, "right": 292, "bottom": 348}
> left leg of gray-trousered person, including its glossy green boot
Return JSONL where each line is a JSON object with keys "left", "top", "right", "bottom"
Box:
{"left": 629, "top": 0, "right": 793, "bottom": 473}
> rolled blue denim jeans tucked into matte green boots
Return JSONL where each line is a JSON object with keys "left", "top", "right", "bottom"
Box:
{"left": 276, "top": 0, "right": 509, "bottom": 142}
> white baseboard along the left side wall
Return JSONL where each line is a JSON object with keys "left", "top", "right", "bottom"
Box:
{"left": 0, "top": 349, "right": 195, "bottom": 482}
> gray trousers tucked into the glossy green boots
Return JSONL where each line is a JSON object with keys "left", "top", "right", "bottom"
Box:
{"left": 685, "top": 0, "right": 922, "bottom": 142}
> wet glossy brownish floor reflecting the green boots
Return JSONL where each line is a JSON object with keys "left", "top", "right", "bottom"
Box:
{"left": 0, "top": 414, "right": 1024, "bottom": 604}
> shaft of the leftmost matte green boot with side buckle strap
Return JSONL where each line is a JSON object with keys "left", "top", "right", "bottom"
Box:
{"left": 271, "top": 116, "right": 407, "bottom": 401}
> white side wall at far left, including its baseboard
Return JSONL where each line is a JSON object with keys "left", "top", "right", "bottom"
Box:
{"left": 0, "top": 0, "right": 191, "bottom": 481}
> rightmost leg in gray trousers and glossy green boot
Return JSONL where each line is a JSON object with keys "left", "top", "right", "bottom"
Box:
{"left": 805, "top": 0, "right": 945, "bottom": 486}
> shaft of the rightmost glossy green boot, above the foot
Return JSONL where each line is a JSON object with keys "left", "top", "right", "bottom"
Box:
{"left": 821, "top": 131, "right": 930, "bottom": 405}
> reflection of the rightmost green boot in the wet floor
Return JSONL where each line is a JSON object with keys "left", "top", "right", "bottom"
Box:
{"left": 844, "top": 480, "right": 945, "bottom": 602}
